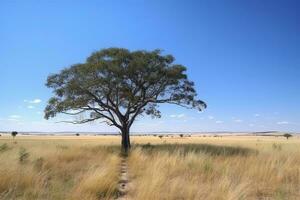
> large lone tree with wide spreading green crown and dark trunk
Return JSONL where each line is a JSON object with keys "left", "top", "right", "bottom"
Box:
{"left": 45, "top": 48, "right": 206, "bottom": 152}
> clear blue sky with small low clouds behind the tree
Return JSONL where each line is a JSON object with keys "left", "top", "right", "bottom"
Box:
{"left": 0, "top": 0, "right": 300, "bottom": 132}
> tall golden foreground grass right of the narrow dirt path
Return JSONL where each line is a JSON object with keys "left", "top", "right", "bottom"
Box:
{"left": 129, "top": 144, "right": 300, "bottom": 200}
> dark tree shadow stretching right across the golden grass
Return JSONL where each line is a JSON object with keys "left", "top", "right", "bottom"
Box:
{"left": 134, "top": 143, "right": 256, "bottom": 156}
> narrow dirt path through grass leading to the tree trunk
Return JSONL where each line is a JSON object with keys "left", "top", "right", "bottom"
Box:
{"left": 117, "top": 158, "right": 130, "bottom": 200}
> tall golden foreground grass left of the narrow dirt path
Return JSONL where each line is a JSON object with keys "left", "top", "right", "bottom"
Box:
{"left": 0, "top": 142, "right": 120, "bottom": 200}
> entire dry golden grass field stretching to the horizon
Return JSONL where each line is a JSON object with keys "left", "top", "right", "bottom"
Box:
{"left": 0, "top": 135, "right": 300, "bottom": 200}
